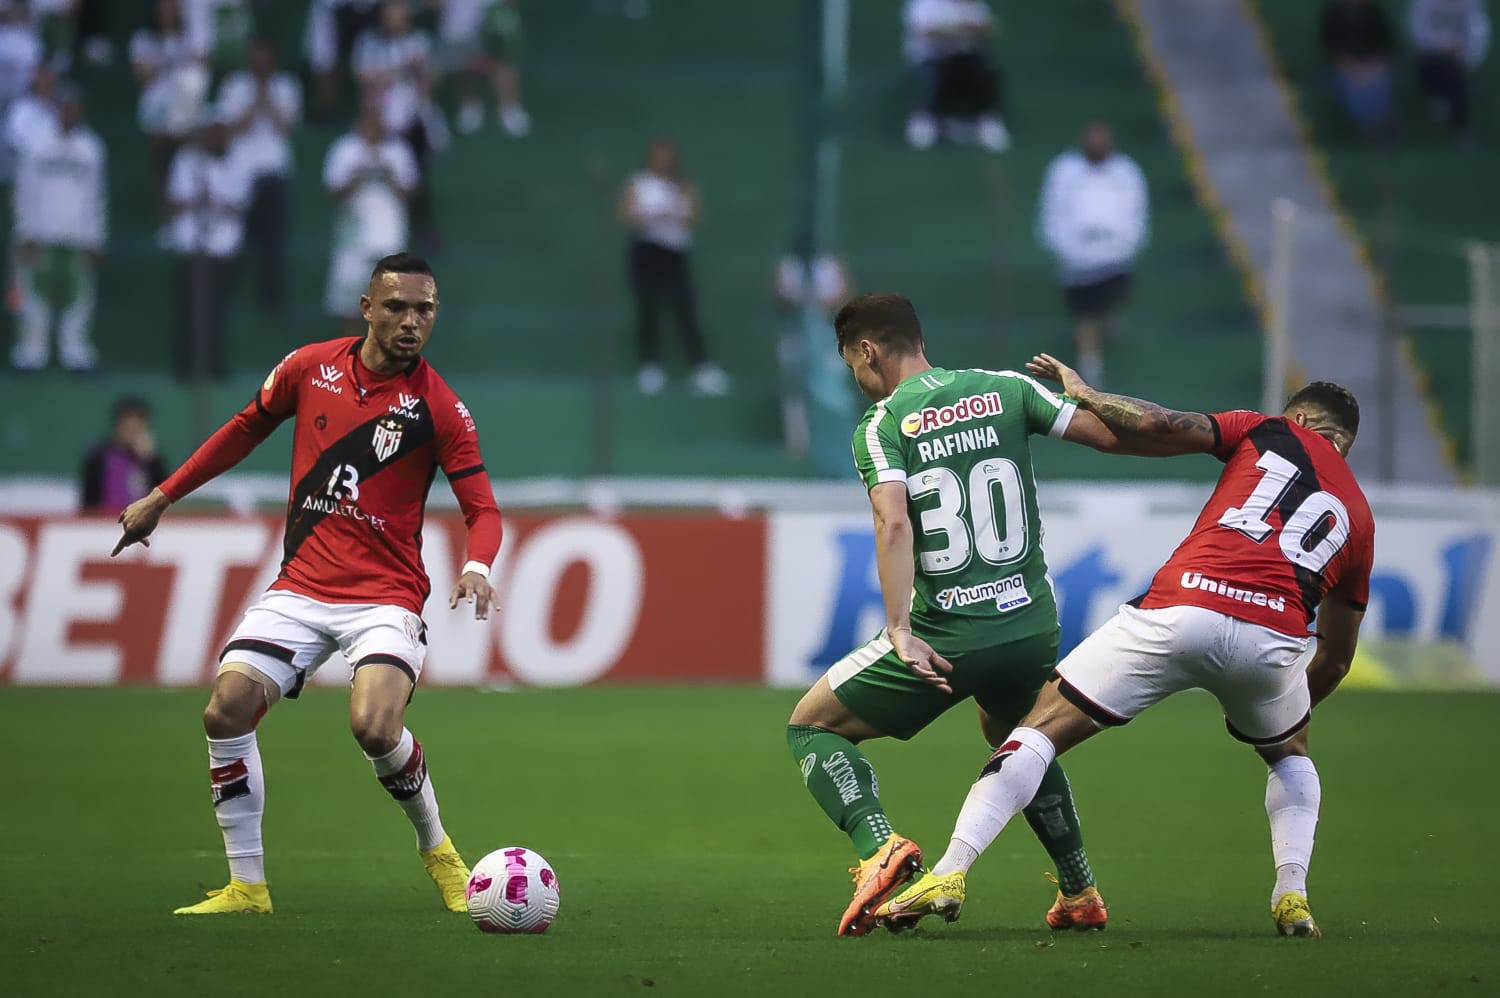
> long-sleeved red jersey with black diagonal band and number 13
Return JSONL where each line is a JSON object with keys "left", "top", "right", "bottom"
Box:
{"left": 162, "top": 336, "right": 501, "bottom": 614}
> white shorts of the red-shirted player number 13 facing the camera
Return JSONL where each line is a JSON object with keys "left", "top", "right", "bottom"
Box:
{"left": 219, "top": 590, "right": 428, "bottom": 698}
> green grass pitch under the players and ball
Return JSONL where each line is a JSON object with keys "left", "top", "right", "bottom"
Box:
{"left": 0, "top": 689, "right": 1500, "bottom": 998}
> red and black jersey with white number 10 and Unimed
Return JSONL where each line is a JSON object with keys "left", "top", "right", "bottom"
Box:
{"left": 1139, "top": 410, "right": 1376, "bottom": 635}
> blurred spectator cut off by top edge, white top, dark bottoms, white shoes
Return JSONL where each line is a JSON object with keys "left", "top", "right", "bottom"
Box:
{"left": 902, "top": 0, "right": 1011, "bottom": 152}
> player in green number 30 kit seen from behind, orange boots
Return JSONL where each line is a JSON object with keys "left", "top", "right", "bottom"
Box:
{"left": 786, "top": 293, "right": 1149, "bottom": 935}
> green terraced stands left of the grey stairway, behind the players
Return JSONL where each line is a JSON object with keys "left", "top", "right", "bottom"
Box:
{"left": 0, "top": 0, "right": 1260, "bottom": 479}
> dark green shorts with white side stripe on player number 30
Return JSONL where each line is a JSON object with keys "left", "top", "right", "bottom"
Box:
{"left": 828, "top": 630, "right": 1061, "bottom": 741}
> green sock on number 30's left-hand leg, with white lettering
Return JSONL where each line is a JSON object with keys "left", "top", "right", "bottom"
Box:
{"left": 786, "top": 725, "right": 891, "bottom": 860}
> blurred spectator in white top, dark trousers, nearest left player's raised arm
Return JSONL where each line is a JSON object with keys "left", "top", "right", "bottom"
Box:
{"left": 167, "top": 117, "right": 251, "bottom": 378}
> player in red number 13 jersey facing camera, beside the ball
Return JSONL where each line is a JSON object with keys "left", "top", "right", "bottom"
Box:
{"left": 114, "top": 254, "right": 501, "bottom": 914}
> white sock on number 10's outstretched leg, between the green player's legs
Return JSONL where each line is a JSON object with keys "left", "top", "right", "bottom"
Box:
{"left": 933, "top": 728, "right": 1058, "bottom": 876}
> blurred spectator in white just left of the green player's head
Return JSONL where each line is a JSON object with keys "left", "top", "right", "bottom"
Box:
{"left": 774, "top": 237, "right": 854, "bottom": 458}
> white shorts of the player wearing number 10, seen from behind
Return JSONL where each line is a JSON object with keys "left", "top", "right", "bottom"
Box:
{"left": 1058, "top": 605, "right": 1311, "bottom": 746}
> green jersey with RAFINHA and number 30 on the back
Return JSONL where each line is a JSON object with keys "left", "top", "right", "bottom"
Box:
{"left": 854, "top": 368, "right": 1077, "bottom": 653}
